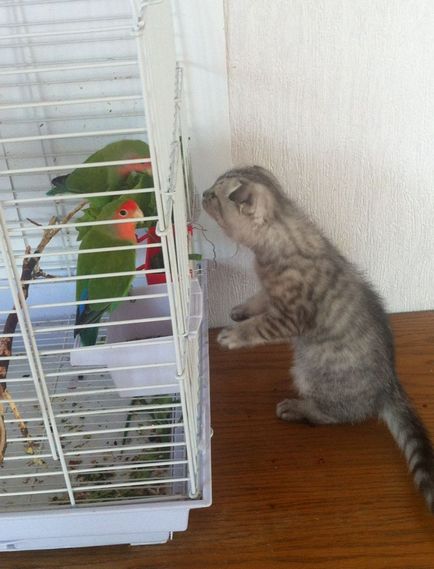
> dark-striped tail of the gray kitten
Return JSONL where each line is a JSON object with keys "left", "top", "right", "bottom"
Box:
{"left": 380, "top": 386, "right": 434, "bottom": 513}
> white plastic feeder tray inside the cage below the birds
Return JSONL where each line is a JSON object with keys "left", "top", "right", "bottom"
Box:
{"left": 70, "top": 279, "right": 203, "bottom": 398}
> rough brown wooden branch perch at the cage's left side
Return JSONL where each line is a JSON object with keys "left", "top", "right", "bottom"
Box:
{"left": 0, "top": 202, "right": 87, "bottom": 464}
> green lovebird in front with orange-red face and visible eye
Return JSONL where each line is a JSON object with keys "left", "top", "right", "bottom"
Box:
{"left": 74, "top": 197, "right": 143, "bottom": 346}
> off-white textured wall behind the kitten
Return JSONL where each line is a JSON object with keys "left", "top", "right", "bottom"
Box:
{"left": 208, "top": 0, "right": 434, "bottom": 325}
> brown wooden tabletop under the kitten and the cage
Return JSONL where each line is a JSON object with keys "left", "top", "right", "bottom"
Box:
{"left": 0, "top": 312, "right": 434, "bottom": 569}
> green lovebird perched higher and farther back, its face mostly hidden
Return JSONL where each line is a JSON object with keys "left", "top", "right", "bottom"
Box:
{"left": 47, "top": 140, "right": 153, "bottom": 210}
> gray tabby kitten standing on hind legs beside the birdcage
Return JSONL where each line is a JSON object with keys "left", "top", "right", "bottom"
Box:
{"left": 203, "top": 166, "right": 434, "bottom": 512}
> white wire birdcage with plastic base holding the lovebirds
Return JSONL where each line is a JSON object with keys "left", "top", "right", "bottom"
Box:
{"left": 0, "top": 0, "right": 210, "bottom": 550}
